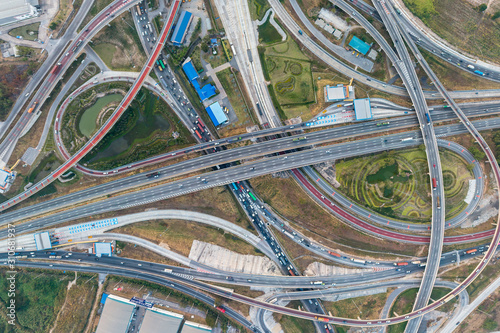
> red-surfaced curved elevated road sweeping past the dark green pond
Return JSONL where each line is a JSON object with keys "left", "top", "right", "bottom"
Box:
{"left": 2, "top": 0, "right": 180, "bottom": 210}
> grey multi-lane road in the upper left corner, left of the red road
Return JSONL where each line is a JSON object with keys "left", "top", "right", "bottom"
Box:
{"left": 0, "top": 0, "right": 143, "bottom": 162}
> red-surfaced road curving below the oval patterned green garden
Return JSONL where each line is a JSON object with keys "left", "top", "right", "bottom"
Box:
{"left": 292, "top": 169, "right": 495, "bottom": 244}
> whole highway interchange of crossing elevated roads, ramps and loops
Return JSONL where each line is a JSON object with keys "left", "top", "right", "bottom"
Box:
{"left": 0, "top": 0, "right": 500, "bottom": 332}
